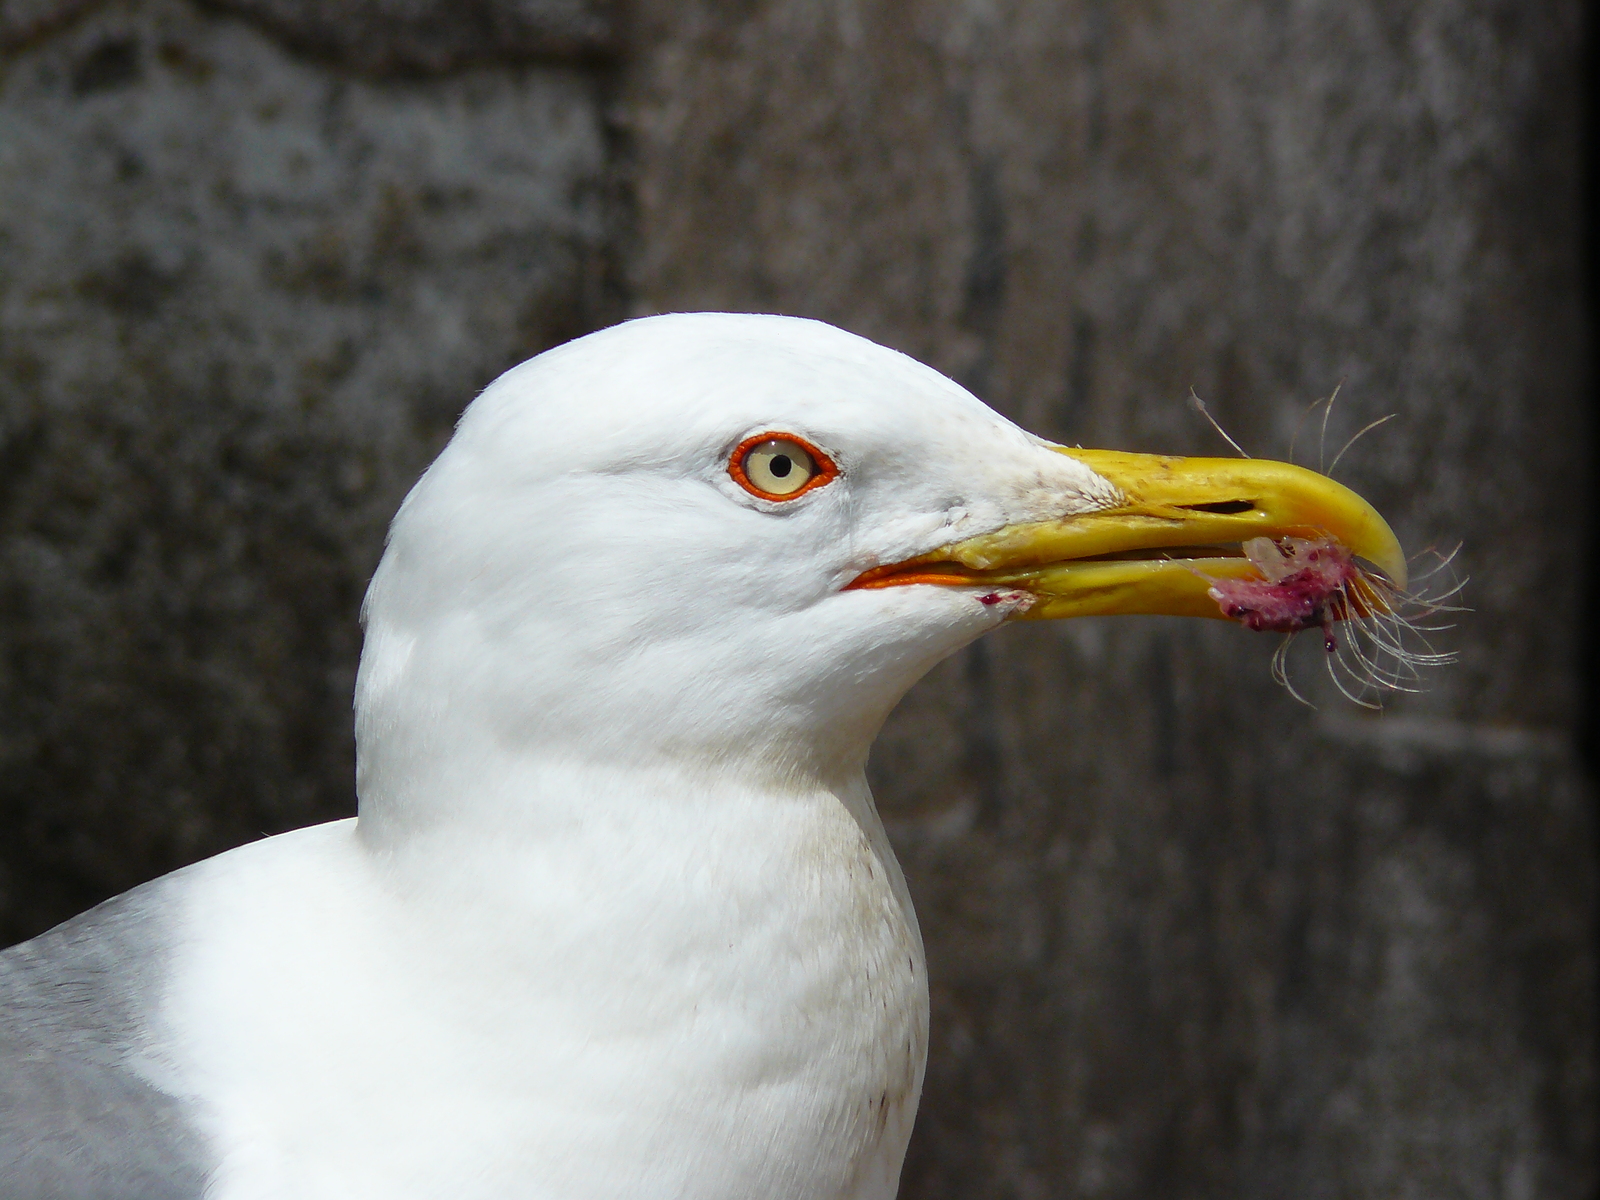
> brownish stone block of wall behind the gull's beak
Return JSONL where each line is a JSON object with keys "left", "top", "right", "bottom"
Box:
{"left": 629, "top": 0, "right": 1594, "bottom": 1200}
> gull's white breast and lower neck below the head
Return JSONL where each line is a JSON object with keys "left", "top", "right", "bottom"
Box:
{"left": 163, "top": 786, "right": 926, "bottom": 1200}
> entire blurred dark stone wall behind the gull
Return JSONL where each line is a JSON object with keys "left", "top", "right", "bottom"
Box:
{"left": 0, "top": 0, "right": 1595, "bottom": 1200}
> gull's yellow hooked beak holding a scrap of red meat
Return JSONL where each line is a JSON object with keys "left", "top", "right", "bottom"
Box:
{"left": 854, "top": 446, "right": 1406, "bottom": 619}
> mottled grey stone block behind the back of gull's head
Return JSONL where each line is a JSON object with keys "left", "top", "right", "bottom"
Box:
{"left": 0, "top": 0, "right": 605, "bottom": 941}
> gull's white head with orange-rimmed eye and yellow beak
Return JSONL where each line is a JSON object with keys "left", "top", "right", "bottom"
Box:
{"left": 357, "top": 314, "right": 1405, "bottom": 824}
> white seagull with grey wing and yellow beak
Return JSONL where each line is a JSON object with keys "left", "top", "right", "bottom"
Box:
{"left": 0, "top": 314, "right": 1405, "bottom": 1200}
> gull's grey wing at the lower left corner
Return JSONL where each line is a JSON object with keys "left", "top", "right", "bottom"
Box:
{"left": 0, "top": 880, "right": 210, "bottom": 1200}
